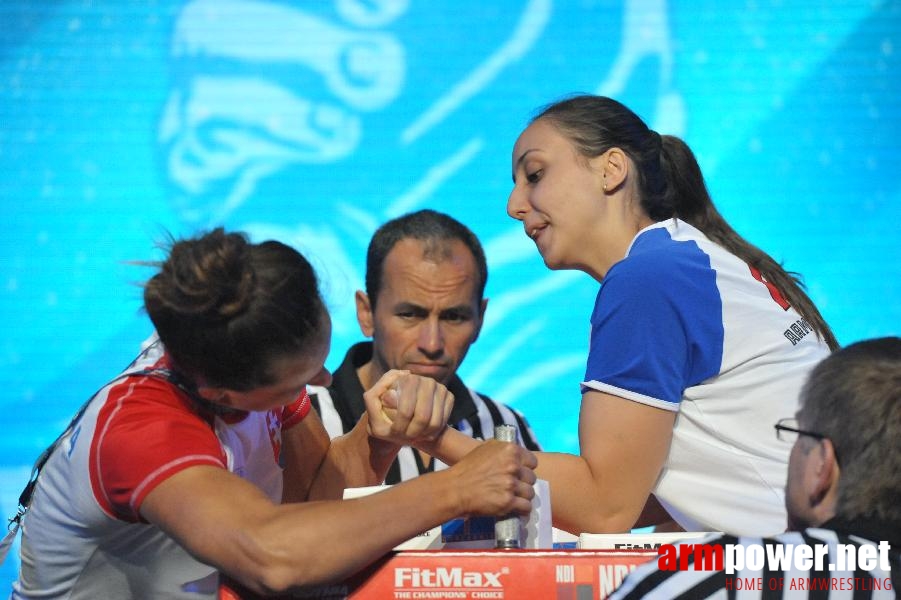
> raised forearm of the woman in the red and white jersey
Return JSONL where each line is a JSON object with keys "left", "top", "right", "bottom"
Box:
{"left": 309, "top": 414, "right": 400, "bottom": 500}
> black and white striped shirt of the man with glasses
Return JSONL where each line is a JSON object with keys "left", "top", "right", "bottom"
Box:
{"left": 609, "top": 519, "right": 901, "bottom": 600}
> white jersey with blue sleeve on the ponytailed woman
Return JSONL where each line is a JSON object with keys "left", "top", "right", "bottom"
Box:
{"left": 582, "top": 219, "right": 829, "bottom": 535}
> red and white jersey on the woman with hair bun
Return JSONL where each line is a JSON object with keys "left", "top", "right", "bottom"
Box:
{"left": 12, "top": 341, "right": 310, "bottom": 600}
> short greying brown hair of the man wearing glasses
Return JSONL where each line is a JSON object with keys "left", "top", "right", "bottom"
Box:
{"left": 799, "top": 337, "right": 901, "bottom": 522}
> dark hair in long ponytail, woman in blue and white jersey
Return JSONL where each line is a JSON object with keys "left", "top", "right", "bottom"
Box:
{"left": 534, "top": 95, "right": 839, "bottom": 350}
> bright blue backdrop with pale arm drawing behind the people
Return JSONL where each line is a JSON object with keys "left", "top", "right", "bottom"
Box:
{"left": 0, "top": 0, "right": 901, "bottom": 589}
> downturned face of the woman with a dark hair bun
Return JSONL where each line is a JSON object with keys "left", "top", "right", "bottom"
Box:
{"left": 217, "top": 316, "right": 332, "bottom": 411}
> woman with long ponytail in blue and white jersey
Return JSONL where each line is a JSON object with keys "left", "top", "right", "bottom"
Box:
{"left": 429, "top": 96, "right": 837, "bottom": 535}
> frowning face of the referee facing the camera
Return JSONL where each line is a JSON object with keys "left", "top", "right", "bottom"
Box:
{"left": 357, "top": 239, "right": 487, "bottom": 383}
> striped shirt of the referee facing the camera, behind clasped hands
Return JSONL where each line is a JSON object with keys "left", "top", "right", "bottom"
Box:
{"left": 308, "top": 342, "right": 541, "bottom": 484}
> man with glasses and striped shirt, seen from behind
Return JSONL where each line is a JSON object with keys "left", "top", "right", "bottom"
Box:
{"left": 611, "top": 337, "right": 901, "bottom": 600}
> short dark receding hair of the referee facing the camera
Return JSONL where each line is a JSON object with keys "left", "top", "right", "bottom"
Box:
{"left": 366, "top": 209, "right": 488, "bottom": 308}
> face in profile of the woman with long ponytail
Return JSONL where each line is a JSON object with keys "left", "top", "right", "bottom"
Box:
{"left": 507, "top": 119, "right": 604, "bottom": 278}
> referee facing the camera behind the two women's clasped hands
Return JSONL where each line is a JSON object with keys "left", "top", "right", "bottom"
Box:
{"left": 309, "top": 210, "right": 540, "bottom": 484}
